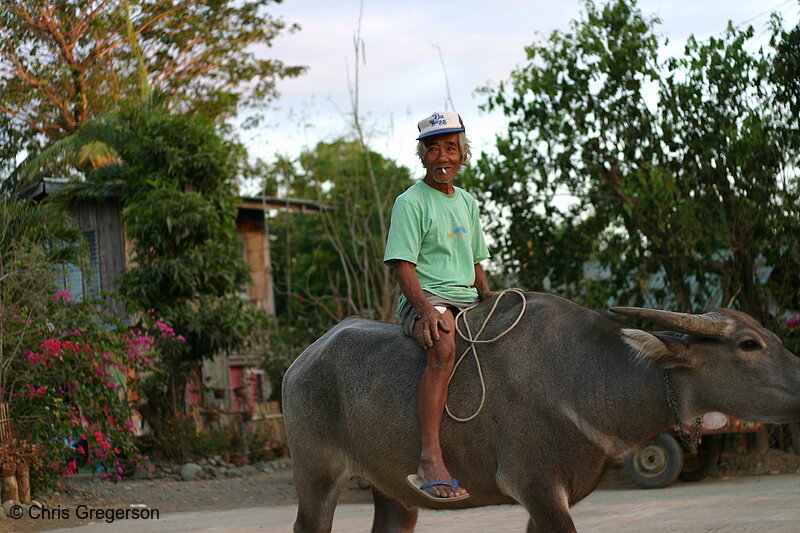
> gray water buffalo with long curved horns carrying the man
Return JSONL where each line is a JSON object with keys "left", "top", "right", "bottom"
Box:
{"left": 283, "top": 293, "right": 800, "bottom": 533}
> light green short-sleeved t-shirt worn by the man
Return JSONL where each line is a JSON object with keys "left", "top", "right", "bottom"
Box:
{"left": 383, "top": 181, "right": 489, "bottom": 314}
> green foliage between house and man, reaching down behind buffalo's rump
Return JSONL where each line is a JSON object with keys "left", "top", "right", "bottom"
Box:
{"left": 265, "top": 140, "right": 411, "bottom": 397}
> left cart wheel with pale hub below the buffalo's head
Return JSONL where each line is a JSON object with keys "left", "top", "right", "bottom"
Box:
{"left": 622, "top": 433, "right": 683, "bottom": 489}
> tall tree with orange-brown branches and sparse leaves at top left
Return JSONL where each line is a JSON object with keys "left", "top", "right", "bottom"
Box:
{"left": 0, "top": 0, "right": 303, "bottom": 178}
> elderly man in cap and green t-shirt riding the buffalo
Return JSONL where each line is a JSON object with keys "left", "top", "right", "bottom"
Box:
{"left": 384, "top": 112, "right": 494, "bottom": 501}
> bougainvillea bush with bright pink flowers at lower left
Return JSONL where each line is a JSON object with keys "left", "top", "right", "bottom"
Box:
{"left": 0, "top": 291, "right": 180, "bottom": 492}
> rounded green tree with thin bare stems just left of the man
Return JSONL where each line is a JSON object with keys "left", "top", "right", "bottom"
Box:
{"left": 277, "top": 140, "right": 411, "bottom": 321}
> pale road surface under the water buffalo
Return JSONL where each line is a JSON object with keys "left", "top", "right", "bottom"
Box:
{"left": 10, "top": 475, "right": 800, "bottom": 533}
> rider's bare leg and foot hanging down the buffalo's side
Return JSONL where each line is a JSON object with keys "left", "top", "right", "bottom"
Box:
{"left": 414, "top": 309, "right": 467, "bottom": 498}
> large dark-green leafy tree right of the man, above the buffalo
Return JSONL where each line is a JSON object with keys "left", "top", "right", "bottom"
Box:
{"left": 476, "top": 0, "right": 800, "bottom": 328}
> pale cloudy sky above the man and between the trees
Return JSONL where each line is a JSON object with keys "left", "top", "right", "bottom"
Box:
{"left": 234, "top": 0, "right": 800, "bottom": 185}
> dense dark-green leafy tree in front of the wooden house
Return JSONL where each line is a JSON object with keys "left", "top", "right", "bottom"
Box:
{"left": 108, "top": 106, "right": 263, "bottom": 370}
